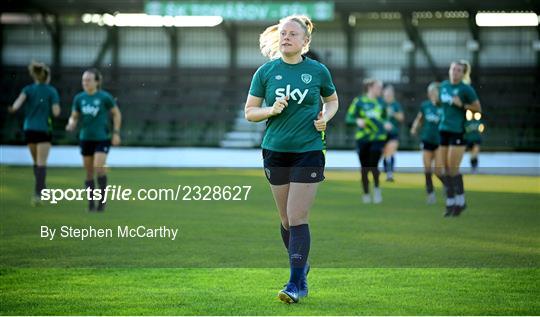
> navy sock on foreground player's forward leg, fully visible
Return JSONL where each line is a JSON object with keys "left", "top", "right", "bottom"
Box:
{"left": 289, "top": 224, "right": 311, "bottom": 287}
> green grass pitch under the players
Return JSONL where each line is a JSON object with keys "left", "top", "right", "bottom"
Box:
{"left": 0, "top": 166, "right": 540, "bottom": 315}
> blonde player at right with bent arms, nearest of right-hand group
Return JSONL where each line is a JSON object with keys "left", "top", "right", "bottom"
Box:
{"left": 439, "top": 60, "right": 481, "bottom": 217}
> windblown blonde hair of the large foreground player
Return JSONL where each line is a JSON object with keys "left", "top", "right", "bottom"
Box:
{"left": 259, "top": 15, "right": 314, "bottom": 59}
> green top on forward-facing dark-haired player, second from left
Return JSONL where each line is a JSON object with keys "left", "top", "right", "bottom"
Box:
{"left": 72, "top": 90, "right": 116, "bottom": 141}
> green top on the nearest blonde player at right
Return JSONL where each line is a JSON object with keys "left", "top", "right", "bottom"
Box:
{"left": 439, "top": 80, "right": 478, "bottom": 133}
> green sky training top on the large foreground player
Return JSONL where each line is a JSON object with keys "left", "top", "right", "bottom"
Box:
{"left": 249, "top": 57, "right": 336, "bottom": 153}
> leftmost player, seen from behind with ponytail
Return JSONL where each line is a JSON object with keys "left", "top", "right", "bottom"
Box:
{"left": 8, "top": 62, "right": 60, "bottom": 206}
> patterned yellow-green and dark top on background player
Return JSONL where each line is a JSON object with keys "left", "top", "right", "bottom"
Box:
{"left": 345, "top": 96, "right": 388, "bottom": 142}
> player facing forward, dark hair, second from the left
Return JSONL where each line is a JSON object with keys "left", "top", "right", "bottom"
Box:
{"left": 66, "top": 69, "right": 122, "bottom": 211}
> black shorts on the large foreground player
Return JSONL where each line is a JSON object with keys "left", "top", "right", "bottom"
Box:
{"left": 262, "top": 149, "right": 326, "bottom": 185}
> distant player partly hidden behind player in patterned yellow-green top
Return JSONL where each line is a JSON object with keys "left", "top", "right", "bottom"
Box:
{"left": 383, "top": 85, "right": 405, "bottom": 182}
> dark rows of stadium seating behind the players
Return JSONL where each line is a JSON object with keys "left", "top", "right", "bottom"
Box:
{"left": 0, "top": 67, "right": 540, "bottom": 151}
